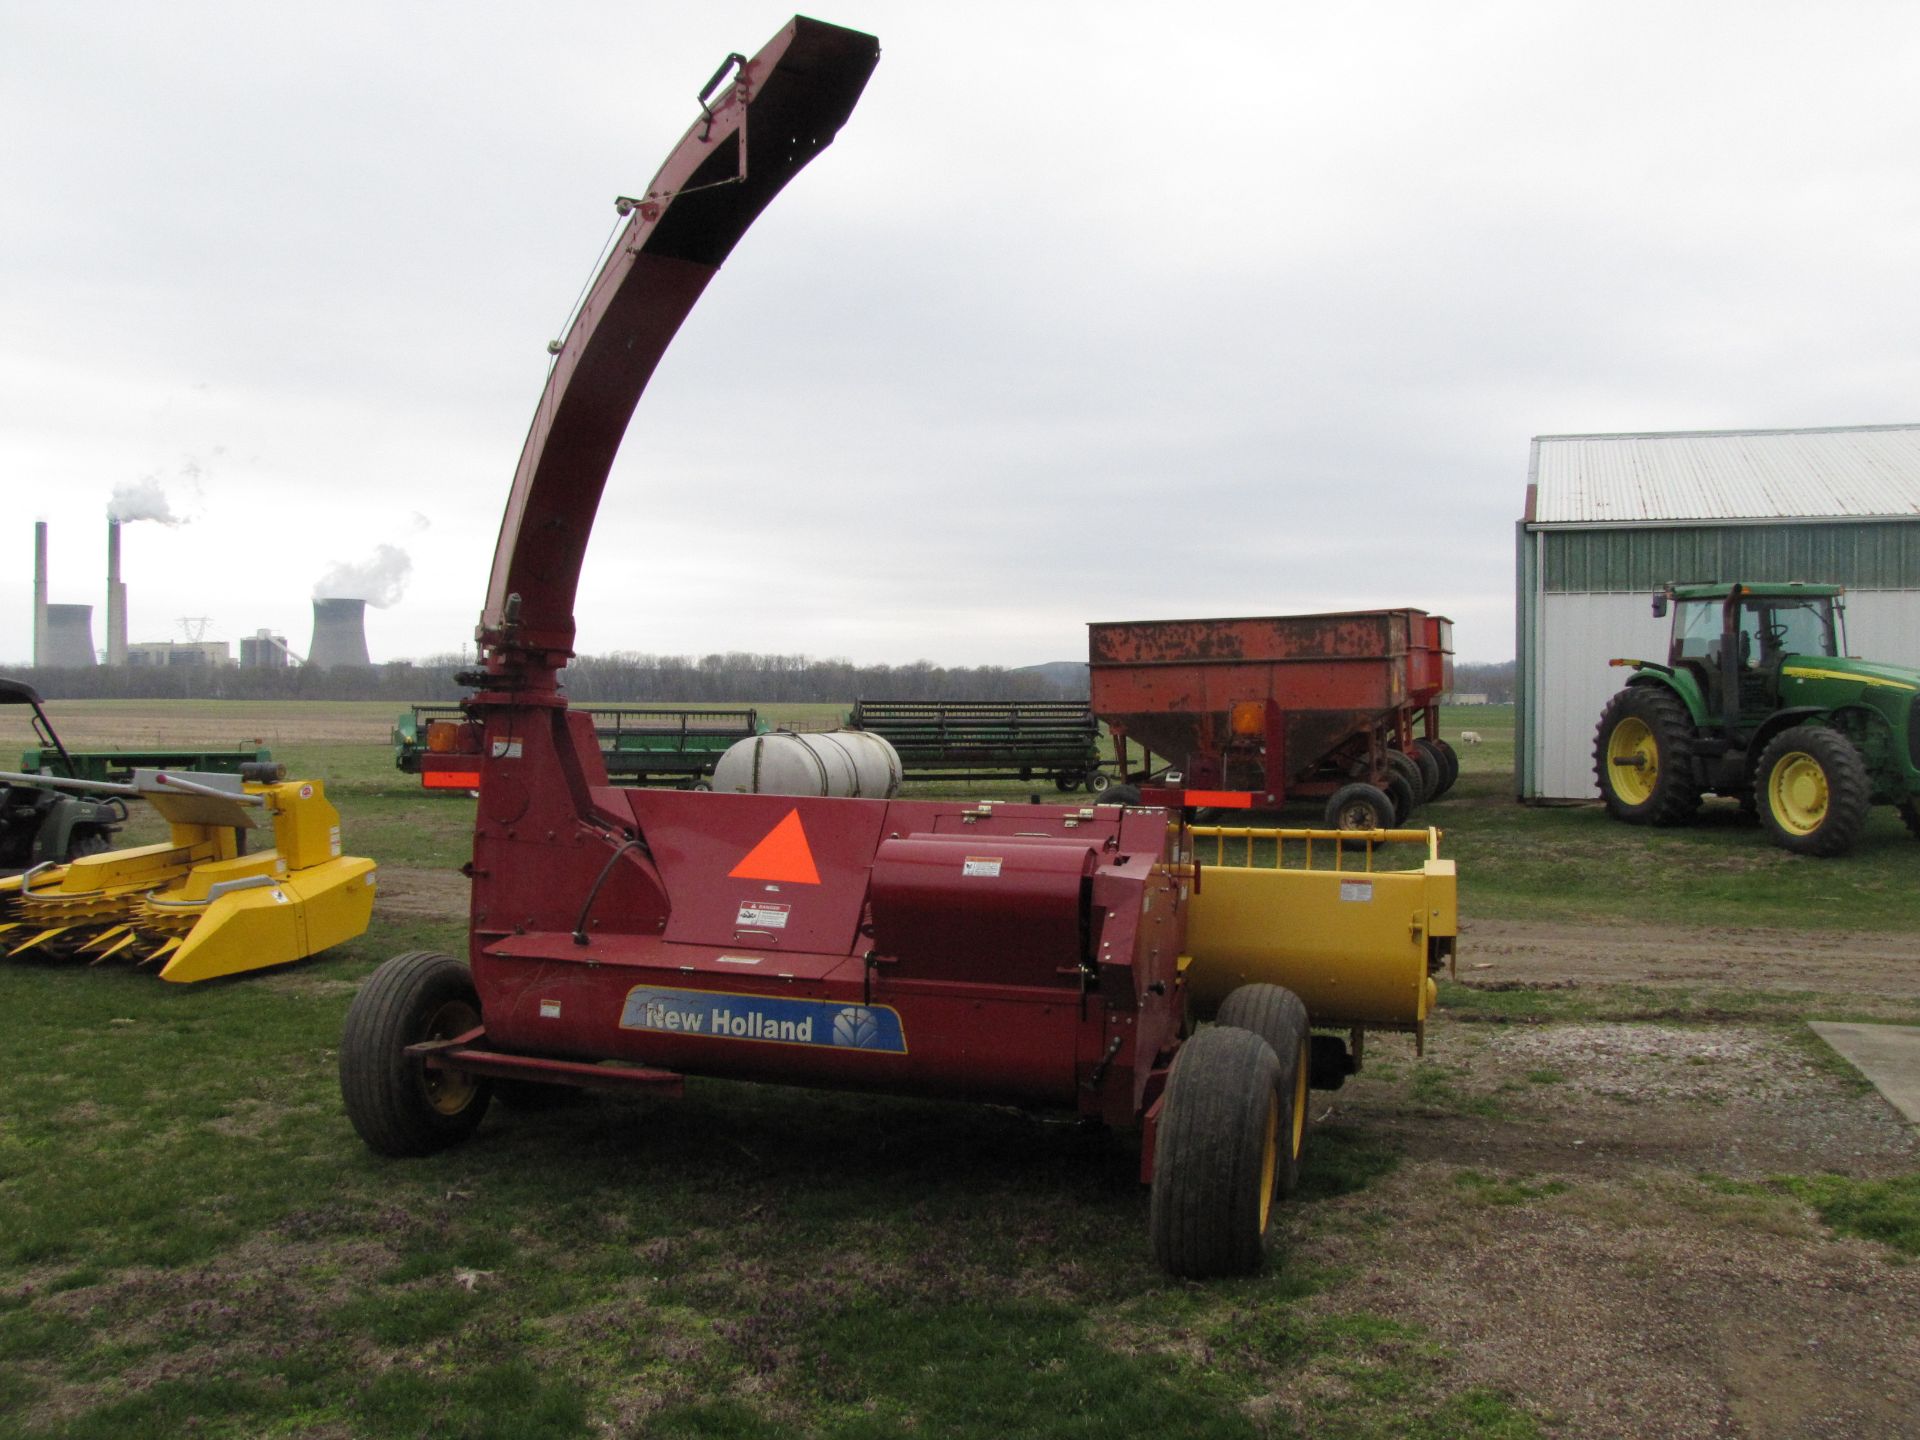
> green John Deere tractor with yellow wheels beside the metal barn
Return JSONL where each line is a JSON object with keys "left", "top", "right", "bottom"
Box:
{"left": 1594, "top": 584, "right": 1920, "bottom": 854}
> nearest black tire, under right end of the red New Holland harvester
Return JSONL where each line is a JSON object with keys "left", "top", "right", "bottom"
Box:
{"left": 1148, "top": 1025, "right": 1281, "bottom": 1279}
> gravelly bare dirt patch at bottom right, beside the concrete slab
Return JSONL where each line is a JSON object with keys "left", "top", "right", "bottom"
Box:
{"left": 1298, "top": 1023, "right": 1920, "bottom": 1440}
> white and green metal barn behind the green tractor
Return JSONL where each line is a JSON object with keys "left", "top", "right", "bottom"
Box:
{"left": 1513, "top": 424, "right": 1920, "bottom": 801}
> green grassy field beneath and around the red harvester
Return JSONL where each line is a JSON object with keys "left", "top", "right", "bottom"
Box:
{"left": 0, "top": 703, "right": 1920, "bottom": 1440}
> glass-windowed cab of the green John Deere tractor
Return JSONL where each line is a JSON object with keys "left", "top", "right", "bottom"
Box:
{"left": 1653, "top": 584, "right": 1845, "bottom": 733}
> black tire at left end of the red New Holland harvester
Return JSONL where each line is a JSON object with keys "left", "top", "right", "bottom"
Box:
{"left": 340, "top": 950, "right": 492, "bottom": 1156}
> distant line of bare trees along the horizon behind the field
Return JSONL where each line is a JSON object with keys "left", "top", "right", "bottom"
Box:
{"left": 12, "top": 651, "right": 1087, "bottom": 705}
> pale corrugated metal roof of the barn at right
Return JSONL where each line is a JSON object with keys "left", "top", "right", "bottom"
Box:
{"left": 1526, "top": 424, "right": 1920, "bottom": 524}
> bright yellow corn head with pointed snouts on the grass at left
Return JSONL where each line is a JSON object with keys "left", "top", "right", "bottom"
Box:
{"left": 0, "top": 770, "right": 374, "bottom": 981}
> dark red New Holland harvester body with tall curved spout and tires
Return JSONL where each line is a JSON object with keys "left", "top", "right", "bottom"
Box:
{"left": 340, "top": 19, "right": 1450, "bottom": 1275}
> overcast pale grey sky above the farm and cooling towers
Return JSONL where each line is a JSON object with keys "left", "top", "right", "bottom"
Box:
{"left": 0, "top": 0, "right": 1920, "bottom": 664}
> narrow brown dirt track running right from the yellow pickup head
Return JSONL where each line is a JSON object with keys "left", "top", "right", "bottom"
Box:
{"left": 1459, "top": 920, "right": 1920, "bottom": 998}
